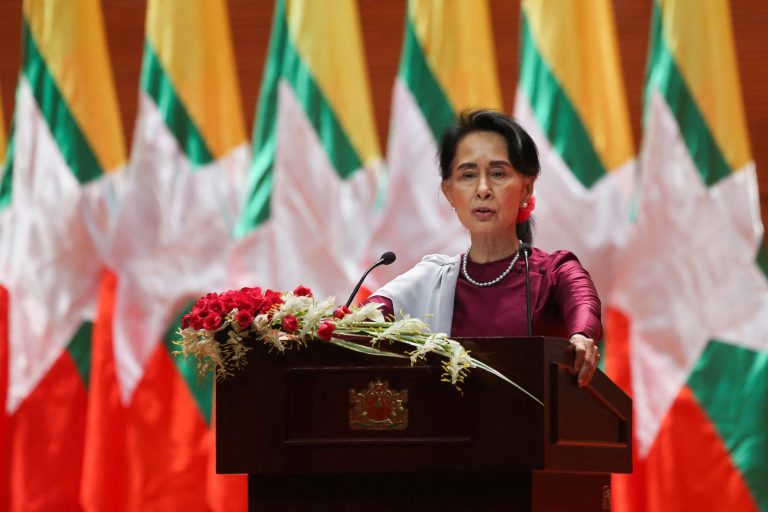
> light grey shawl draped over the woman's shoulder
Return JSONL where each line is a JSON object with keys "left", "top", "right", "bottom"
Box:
{"left": 373, "top": 254, "right": 461, "bottom": 335}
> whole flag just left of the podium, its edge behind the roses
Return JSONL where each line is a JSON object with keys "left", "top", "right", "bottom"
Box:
{"left": 84, "top": 0, "right": 248, "bottom": 510}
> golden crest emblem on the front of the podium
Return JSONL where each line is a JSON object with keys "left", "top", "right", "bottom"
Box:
{"left": 349, "top": 380, "right": 408, "bottom": 430}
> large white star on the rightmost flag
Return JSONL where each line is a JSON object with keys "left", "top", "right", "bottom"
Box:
{"left": 611, "top": 92, "right": 768, "bottom": 456}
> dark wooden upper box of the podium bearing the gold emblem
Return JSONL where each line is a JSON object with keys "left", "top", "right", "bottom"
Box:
{"left": 216, "top": 338, "right": 631, "bottom": 475}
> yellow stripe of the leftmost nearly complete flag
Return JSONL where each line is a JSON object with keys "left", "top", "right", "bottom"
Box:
{"left": 24, "top": 0, "right": 126, "bottom": 172}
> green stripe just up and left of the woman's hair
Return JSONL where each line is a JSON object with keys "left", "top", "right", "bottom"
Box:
{"left": 399, "top": 13, "right": 456, "bottom": 141}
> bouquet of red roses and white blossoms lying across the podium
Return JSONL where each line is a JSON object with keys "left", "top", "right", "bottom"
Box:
{"left": 176, "top": 286, "right": 543, "bottom": 405}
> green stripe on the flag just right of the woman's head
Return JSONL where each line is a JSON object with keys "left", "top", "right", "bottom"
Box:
{"left": 520, "top": 15, "right": 606, "bottom": 188}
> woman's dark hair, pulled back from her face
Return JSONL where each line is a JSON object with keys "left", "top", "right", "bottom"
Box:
{"left": 438, "top": 109, "right": 541, "bottom": 243}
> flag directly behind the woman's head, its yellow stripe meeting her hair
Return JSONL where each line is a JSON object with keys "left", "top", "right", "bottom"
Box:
{"left": 367, "top": 0, "right": 502, "bottom": 284}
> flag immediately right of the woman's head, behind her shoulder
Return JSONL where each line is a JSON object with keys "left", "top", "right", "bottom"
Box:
{"left": 515, "top": 0, "right": 635, "bottom": 296}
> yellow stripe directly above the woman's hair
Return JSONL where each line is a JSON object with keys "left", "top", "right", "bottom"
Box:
{"left": 408, "top": 0, "right": 502, "bottom": 112}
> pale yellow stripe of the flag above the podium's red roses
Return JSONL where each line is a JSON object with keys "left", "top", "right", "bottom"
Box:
{"left": 286, "top": 0, "right": 381, "bottom": 165}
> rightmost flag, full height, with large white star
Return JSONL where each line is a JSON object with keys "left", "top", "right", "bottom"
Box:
{"left": 611, "top": 0, "right": 768, "bottom": 511}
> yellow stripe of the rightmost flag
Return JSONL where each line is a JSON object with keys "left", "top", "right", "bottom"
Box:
{"left": 659, "top": 0, "right": 752, "bottom": 170}
